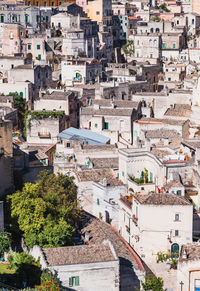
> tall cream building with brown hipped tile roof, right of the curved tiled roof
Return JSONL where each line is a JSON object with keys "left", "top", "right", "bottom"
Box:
{"left": 119, "top": 193, "right": 193, "bottom": 263}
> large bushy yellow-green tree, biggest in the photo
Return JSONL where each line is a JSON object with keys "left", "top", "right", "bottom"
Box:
{"left": 8, "top": 171, "right": 81, "bottom": 248}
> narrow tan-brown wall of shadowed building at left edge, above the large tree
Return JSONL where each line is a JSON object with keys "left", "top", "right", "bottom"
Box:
{"left": 0, "top": 119, "right": 13, "bottom": 196}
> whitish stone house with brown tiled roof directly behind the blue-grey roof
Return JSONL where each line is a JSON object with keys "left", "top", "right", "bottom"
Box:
{"left": 80, "top": 100, "right": 141, "bottom": 147}
